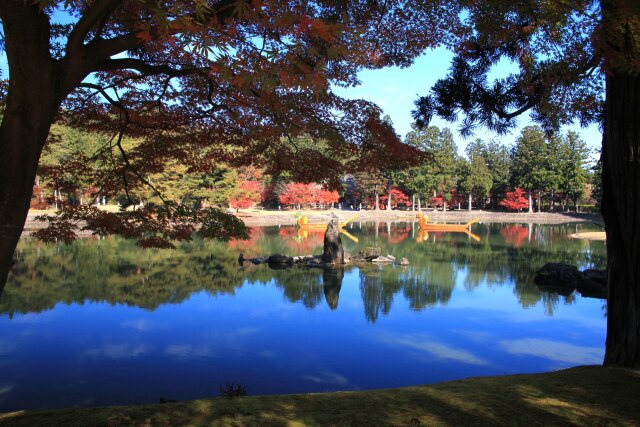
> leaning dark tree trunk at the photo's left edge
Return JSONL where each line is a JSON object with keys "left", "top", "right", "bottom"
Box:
{"left": 0, "top": 1, "right": 60, "bottom": 293}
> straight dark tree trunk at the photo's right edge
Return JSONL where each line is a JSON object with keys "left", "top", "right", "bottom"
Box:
{"left": 602, "top": 70, "right": 640, "bottom": 368}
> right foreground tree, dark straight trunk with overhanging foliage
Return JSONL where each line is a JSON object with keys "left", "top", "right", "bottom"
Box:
{"left": 415, "top": 0, "right": 640, "bottom": 368}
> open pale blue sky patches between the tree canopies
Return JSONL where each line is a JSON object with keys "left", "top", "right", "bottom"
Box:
{"left": 335, "top": 49, "right": 602, "bottom": 158}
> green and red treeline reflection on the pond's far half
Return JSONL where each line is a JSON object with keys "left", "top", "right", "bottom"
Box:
{"left": 0, "top": 223, "right": 605, "bottom": 323}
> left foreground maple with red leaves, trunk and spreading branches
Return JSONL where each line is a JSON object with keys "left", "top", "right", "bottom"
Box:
{"left": 0, "top": 0, "right": 457, "bottom": 286}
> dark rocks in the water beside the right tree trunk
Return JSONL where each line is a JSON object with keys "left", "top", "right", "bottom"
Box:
{"left": 534, "top": 263, "right": 607, "bottom": 299}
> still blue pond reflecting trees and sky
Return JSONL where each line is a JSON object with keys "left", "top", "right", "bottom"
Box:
{"left": 0, "top": 222, "right": 606, "bottom": 411}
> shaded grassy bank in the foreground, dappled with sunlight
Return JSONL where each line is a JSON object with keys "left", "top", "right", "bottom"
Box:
{"left": 0, "top": 366, "right": 640, "bottom": 426}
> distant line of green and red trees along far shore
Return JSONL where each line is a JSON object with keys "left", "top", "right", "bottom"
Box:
{"left": 31, "top": 122, "right": 601, "bottom": 211}
